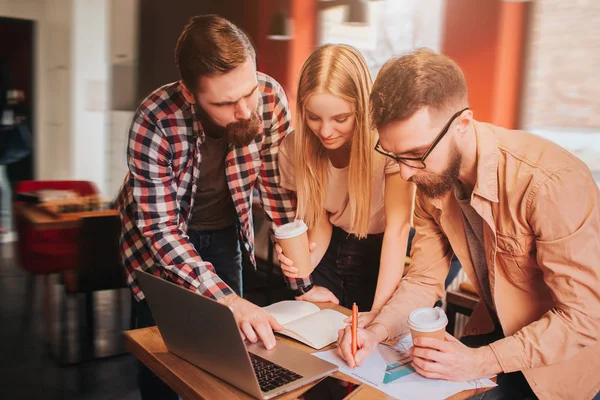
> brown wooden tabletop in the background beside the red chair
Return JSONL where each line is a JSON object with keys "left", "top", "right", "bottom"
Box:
{"left": 14, "top": 203, "right": 119, "bottom": 230}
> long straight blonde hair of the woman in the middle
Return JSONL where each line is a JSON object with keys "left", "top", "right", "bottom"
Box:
{"left": 294, "top": 44, "right": 377, "bottom": 238}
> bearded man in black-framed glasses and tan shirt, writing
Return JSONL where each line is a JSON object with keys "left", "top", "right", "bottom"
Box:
{"left": 339, "top": 49, "right": 600, "bottom": 399}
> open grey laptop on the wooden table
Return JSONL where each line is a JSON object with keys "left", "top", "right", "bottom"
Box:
{"left": 135, "top": 270, "right": 338, "bottom": 399}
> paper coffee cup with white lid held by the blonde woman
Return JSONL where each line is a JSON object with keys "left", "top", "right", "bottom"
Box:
{"left": 275, "top": 219, "right": 314, "bottom": 278}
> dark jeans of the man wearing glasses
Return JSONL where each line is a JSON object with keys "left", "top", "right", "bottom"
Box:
{"left": 460, "top": 326, "right": 537, "bottom": 400}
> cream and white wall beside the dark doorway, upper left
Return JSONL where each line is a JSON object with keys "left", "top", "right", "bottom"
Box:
{"left": 0, "top": 0, "right": 110, "bottom": 193}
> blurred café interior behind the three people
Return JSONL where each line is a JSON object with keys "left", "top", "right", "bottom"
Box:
{"left": 0, "top": 0, "right": 600, "bottom": 399}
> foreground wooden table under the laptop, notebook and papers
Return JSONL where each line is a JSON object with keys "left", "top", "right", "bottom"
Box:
{"left": 125, "top": 303, "right": 494, "bottom": 400}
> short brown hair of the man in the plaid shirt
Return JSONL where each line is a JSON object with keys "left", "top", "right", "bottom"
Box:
{"left": 175, "top": 14, "right": 256, "bottom": 90}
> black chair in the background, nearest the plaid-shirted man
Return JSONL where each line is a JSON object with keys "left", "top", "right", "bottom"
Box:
{"left": 61, "top": 215, "right": 133, "bottom": 362}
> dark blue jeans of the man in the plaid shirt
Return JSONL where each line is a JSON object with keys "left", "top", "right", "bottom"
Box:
{"left": 134, "top": 226, "right": 242, "bottom": 400}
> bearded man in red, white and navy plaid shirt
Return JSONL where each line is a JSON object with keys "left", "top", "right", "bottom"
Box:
{"left": 117, "top": 15, "right": 309, "bottom": 399}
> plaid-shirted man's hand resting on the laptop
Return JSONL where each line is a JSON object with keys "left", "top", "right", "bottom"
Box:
{"left": 219, "top": 294, "right": 283, "bottom": 350}
